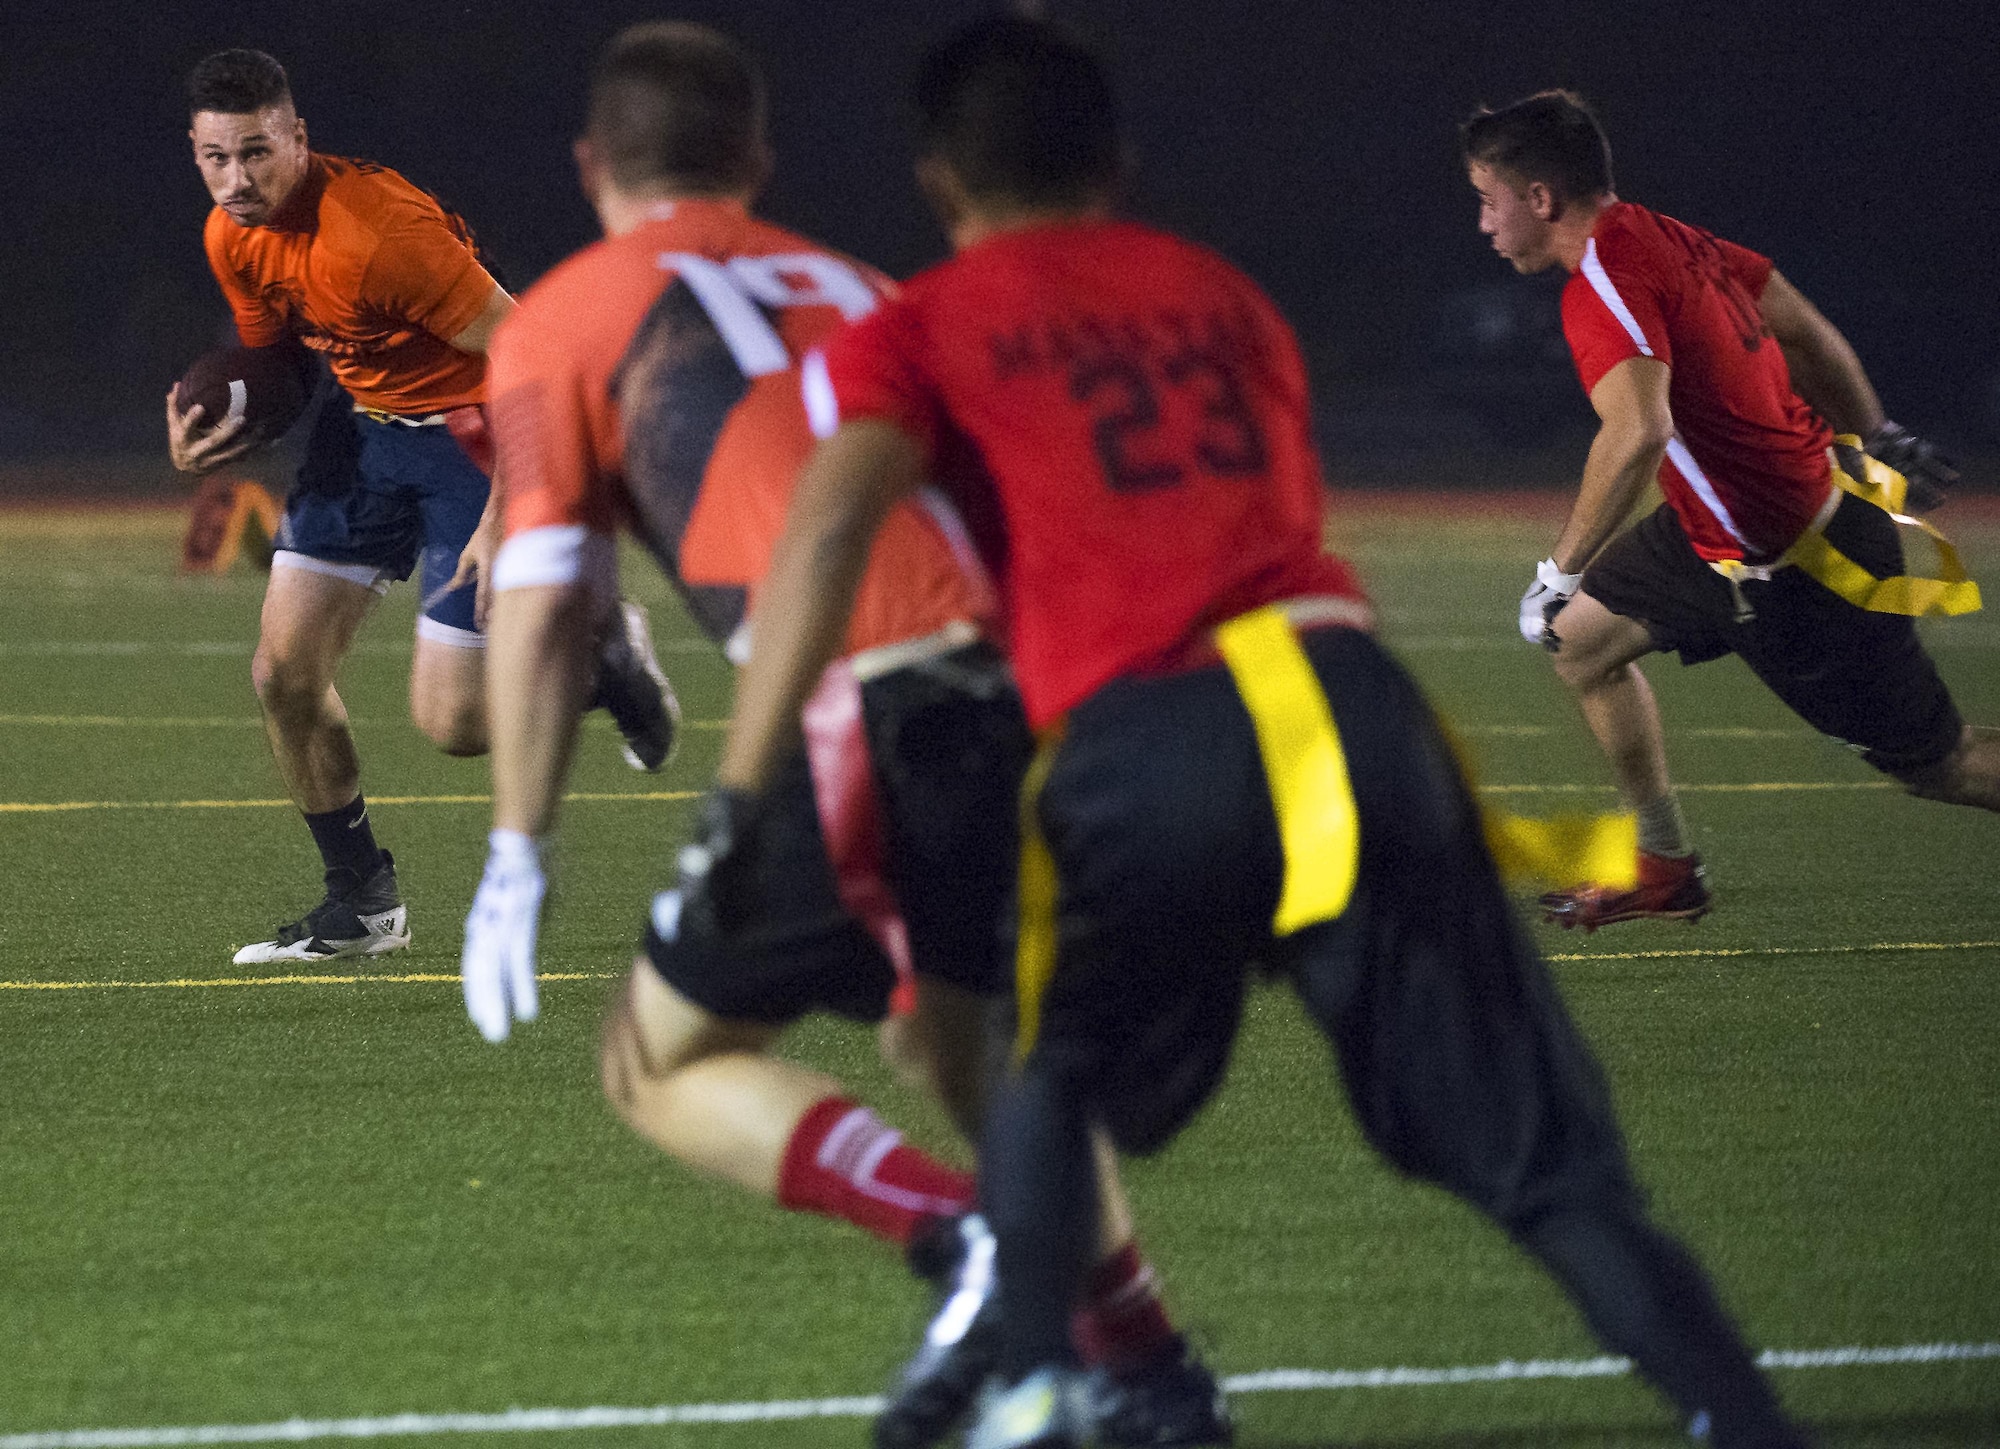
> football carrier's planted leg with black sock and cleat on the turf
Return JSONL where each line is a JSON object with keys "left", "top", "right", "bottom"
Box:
{"left": 236, "top": 554, "right": 410, "bottom": 965}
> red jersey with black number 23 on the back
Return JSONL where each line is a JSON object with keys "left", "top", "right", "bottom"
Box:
{"left": 828, "top": 220, "right": 1360, "bottom": 727}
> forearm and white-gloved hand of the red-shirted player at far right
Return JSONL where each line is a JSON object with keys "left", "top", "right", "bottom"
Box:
{"left": 1520, "top": 356, "right": 1674, "bottom": 648}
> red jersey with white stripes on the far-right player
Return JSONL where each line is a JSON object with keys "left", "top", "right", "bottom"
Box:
{"left": 1562, "top": 202, "right": 1832, "bottom": 562}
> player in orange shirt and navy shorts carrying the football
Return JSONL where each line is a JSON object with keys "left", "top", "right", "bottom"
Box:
{"left": 166, "top": 50, "right": 678, "bottom": 965}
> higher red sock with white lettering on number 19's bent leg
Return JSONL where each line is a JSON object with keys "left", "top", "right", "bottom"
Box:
{"left": 778, "top": 1097, "right": 972, "bottom": 1245}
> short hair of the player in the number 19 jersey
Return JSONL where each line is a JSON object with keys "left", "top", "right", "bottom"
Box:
{"left": 586, "top": 20, "right": 766, "bottom": 192}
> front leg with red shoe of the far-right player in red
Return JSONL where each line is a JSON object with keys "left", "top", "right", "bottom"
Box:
{"left": 1542, "top": 594, "right": 1710, "bottom": 931}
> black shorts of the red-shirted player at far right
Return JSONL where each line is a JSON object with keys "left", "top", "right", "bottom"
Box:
{"left": 1582, "top": 494, "right": 1964, "bottom": 775}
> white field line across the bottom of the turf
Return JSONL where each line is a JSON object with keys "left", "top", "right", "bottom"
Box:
{"left": 0, "top": 1343, "right": 2000, "bottom": 1449}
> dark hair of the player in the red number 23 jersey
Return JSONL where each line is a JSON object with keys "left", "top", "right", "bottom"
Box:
{"left": 916, "top": 14, "right": 1120, "bottom": 206}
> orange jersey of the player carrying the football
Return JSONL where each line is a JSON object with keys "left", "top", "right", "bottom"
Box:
{"left": 202, "top": 154, "right": 498, "bottom": 416}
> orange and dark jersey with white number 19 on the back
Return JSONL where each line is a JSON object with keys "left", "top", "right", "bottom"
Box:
{"left": 490, "top": 200, "right": 990, "bottom": 652}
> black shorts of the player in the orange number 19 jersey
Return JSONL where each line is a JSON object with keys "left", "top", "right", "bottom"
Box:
{"left": 644, "top": 644, "right": 1034, "bottom": 1023}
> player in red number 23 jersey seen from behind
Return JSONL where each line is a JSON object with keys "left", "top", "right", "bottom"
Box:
{"left": 698, "top": 18, "right": 1800, "bottom": 1449}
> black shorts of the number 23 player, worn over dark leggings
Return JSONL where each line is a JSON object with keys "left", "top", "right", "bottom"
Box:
{"left": 1034, "top": 628, "right": 1634, "bottom": 1227}
